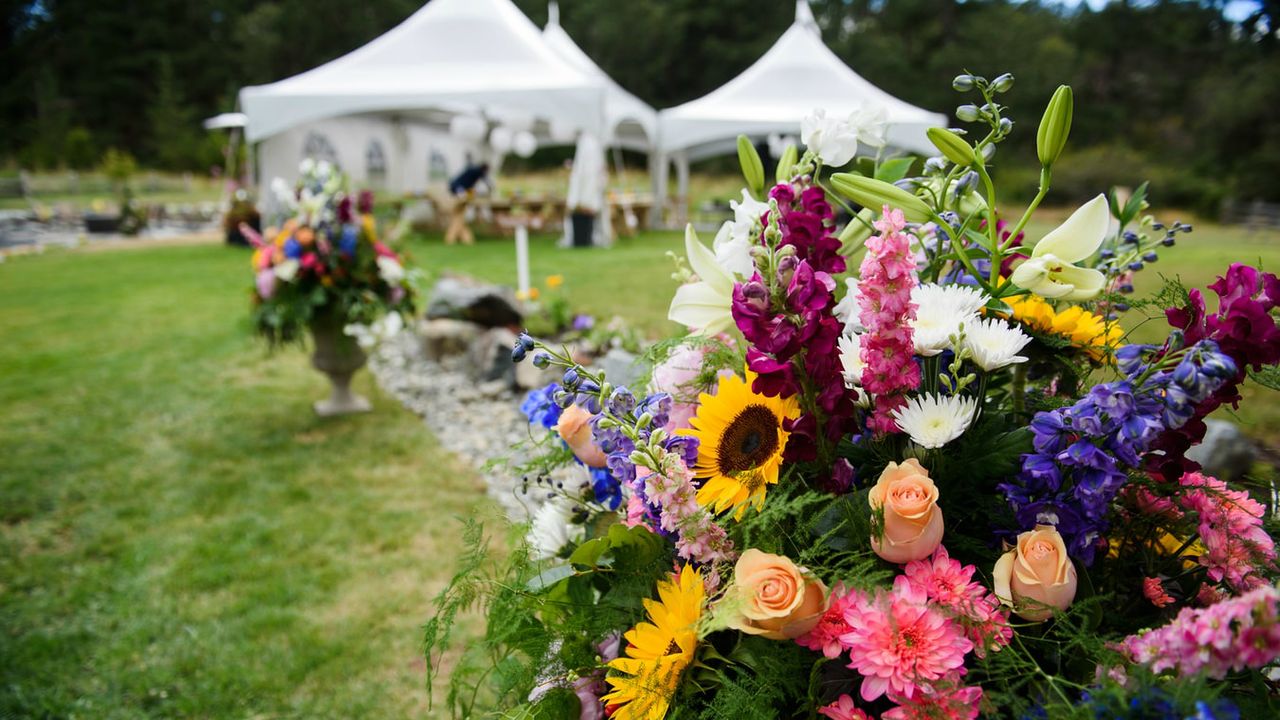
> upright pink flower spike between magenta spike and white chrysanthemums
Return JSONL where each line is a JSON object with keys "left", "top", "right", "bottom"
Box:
{"left": 858, "top": 205, "right": 920, "bottom": 433}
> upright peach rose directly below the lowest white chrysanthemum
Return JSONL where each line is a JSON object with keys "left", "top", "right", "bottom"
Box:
{"left": 867, "top": 457, "right": 942, "bottom": 564}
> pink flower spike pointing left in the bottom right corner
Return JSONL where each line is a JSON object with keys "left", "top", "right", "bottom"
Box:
{"left": 1120, "top": 585, "right": 1280, "bottom": 679}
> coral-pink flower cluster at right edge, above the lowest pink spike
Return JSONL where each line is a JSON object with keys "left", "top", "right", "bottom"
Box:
{"left": 1178, "top": 473, "right": 1276, "bottom": 591}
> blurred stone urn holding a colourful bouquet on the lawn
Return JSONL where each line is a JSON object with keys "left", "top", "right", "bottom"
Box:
{"left": 239, "top": 160, "right": 415, "bottom": 415}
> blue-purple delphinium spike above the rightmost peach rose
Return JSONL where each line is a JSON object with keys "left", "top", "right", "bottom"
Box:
{"left": 1000, "top": 340, "right": 1235, "bottom": 565}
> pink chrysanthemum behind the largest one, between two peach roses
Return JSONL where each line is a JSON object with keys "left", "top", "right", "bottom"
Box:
{"left": 904, "top": 546, "right": 1014, "bottom": 657}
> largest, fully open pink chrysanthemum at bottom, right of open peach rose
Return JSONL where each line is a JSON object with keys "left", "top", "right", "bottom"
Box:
{"left": 840, "top": 575, "right": 973, "bottom": 701}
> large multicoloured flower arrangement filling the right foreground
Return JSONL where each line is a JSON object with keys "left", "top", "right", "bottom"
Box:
{"left": 426, "top": 74, "right": 1280, "bottom": 720}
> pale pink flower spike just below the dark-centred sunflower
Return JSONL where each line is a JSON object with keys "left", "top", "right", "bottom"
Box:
{"left": 628, "top": 452, "right": 735, "bottom": 562}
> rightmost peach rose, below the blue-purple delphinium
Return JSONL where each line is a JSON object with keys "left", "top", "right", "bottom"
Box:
{"left": 992, "top": 525, "right": 1076, "bottom": 623}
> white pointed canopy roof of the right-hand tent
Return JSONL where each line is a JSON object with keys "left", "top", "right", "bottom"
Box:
{"left": 658, "top": 0, "right": 947, "bottom": 159}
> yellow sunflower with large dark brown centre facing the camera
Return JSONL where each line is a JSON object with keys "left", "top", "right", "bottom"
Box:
{"left": 681, "top": 370, "right": 800, "bottom": 519}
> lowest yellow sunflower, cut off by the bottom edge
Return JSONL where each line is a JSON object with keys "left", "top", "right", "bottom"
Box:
{"left": 600, "top": 565, "right": 707, "bottom": 720}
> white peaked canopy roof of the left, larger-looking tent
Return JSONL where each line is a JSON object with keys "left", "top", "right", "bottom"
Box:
{"left": 239, "top": 0, "right": 604, "bottom": 141}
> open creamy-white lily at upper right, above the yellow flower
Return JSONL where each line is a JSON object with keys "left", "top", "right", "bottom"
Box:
{"left": 1009, "top": 195, "right": 1111, "bottom": 300}
